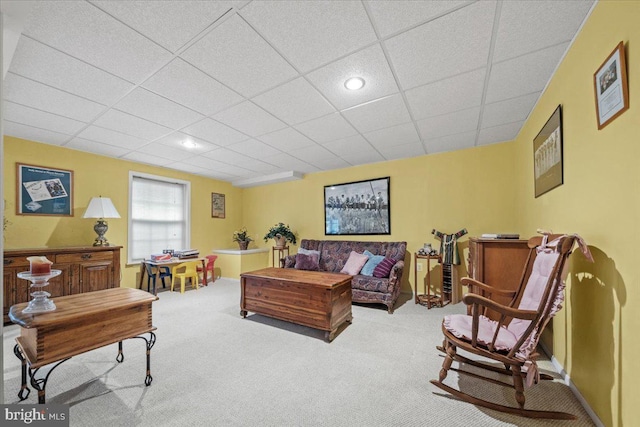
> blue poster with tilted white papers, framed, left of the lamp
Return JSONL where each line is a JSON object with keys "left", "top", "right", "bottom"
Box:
{"left": 16, "top": 163, "right": 73, "bottom": 216}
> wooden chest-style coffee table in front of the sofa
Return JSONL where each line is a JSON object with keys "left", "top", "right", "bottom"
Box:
{"left": 240, "top": 268, "right": 353, "bottom": 342}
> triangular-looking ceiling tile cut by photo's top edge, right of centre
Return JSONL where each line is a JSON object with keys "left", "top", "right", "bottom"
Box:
{"left": 366, "top": 0, "right": 470, "bottom": 37}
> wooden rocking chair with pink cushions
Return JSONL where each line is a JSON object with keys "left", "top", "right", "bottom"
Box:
{"left": 431, "top": 233, "right": 593, "bottom": 420}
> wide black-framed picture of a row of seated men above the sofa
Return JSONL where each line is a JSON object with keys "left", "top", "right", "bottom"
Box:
{"left": 324, "top": 177, "right": 391, "bottom": 235}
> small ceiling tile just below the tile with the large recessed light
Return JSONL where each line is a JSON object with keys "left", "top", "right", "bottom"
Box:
{"left": 342, "top": 93, "right": 411, "bottom": 132}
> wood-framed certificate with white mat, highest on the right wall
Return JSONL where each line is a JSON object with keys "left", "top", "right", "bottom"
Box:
{"left": 593, "top": 42, "right": 629, "bottom": 129}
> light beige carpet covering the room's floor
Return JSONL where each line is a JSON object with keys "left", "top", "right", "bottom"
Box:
{"left": 4, "top": 279, "right": 593, "bottom": 427}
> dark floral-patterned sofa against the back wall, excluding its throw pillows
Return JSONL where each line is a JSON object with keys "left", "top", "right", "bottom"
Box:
{"left": 282, "top": 239, "right": 407, "bottom": 314}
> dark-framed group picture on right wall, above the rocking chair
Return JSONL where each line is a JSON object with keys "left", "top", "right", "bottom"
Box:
{"left": 533, "top": 105, "right": 563, "bottom": 197}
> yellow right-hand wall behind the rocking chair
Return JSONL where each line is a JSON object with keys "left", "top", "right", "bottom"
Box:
{"left": 515, "top": 1, "right": 640, "bottom": 426}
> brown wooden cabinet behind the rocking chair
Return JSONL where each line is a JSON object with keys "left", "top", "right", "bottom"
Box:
{"left": 469, "top": 237, "right": 529, "bottom": 319}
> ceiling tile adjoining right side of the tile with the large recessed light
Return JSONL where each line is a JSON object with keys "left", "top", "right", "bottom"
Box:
{"left": 385, "top": 1, "right": 496, "bottom": 90}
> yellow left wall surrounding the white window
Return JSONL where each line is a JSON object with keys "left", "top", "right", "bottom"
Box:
{"left": 3, "top": 137, "right": 242, "bottom": 287}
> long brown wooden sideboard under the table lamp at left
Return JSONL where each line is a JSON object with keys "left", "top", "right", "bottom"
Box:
{"left": 2, "top": 246, "right": 122, "bottom": 323}
